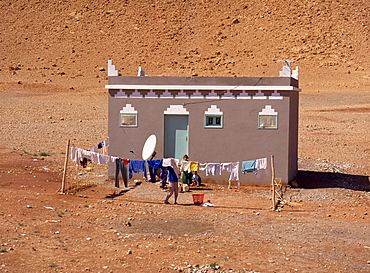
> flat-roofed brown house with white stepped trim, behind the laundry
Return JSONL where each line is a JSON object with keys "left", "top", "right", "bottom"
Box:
{"left": 106, "top": 61, "right": 301, "bottom": 186}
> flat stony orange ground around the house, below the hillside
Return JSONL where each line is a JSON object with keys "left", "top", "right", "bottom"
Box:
{"left": 0, "top": 83, "right": 370, "bottom": 272}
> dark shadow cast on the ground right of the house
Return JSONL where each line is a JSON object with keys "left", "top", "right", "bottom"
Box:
{"left": 294, "top": 171, "right": 370, "bottom": 191}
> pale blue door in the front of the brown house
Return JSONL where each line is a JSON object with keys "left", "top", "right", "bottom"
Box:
{"left": 164, "top": 115, "right": 188, "bottom": 160}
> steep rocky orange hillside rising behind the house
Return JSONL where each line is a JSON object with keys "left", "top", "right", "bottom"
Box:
{"left": 0, "top": 0, "right": 370, "bottom": 90}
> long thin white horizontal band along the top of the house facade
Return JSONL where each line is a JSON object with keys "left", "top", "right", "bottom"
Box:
{"left": 105, "top": 84, "right": 302, "bottom": 92}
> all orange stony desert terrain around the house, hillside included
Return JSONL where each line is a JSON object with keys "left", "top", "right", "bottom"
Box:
{"left": 0, "top": 0, "right": 370, "bottom": 272}
